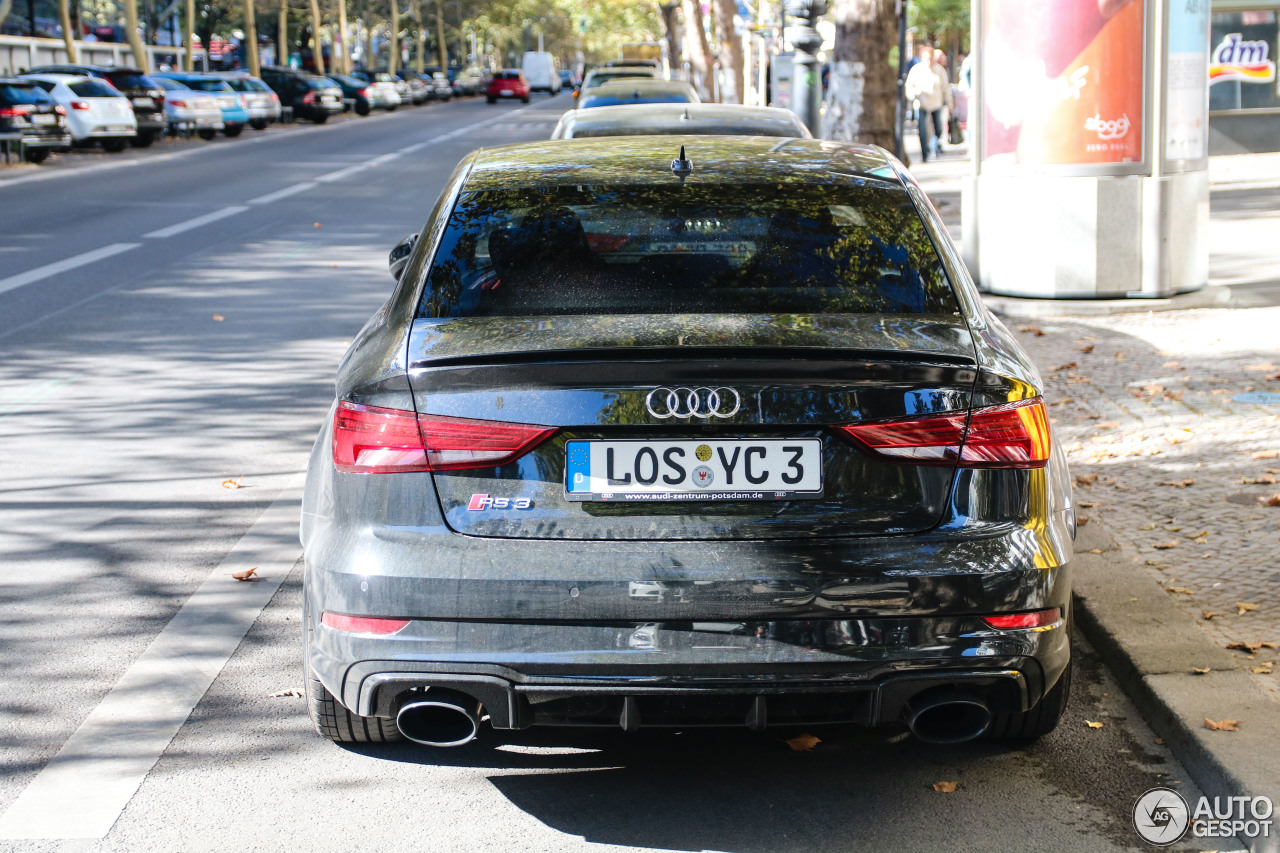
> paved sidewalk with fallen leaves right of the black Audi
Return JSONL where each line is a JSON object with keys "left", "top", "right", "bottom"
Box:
{"left": 908, "top": 141, "right": 1280, "bottom": 835}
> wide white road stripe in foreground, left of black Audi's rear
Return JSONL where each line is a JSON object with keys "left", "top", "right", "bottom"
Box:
{"left": 0, "top": 474, "right": 303, "bottom": 839}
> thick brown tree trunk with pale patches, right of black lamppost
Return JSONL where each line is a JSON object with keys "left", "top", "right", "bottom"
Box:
{"left": 823, "top": 0, "right": 897, "bottom": 151}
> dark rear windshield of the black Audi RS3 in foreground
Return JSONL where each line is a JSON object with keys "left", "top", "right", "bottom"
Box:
{"left": 419, "top": 182, "right": 959, "bottom": 318}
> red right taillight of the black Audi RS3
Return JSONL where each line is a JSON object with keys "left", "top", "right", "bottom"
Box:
{"left": 837, "top": 397, "right": 1050, "bottom": 467}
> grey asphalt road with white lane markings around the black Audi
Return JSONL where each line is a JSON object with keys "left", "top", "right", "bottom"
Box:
{"left": 0, "top": 97, "right": 1218, "bottom": 853}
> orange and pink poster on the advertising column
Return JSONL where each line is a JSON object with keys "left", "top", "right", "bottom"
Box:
{"left": 982, "top": 0, "right": 1152, "bottom": 167}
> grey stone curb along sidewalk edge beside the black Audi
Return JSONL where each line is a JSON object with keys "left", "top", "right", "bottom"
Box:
{"left": 1073, "top": 519, "right": 1280, "bottom": 853}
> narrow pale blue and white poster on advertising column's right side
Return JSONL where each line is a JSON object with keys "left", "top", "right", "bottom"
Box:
{"left": 1165, "top": 0, "right": 1210, "bottom": 160}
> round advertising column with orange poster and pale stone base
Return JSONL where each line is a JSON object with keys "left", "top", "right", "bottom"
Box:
{"left": 964, "top": 0, "right": 1208, "bottom": 298}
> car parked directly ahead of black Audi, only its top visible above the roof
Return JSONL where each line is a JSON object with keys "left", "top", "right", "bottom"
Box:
{"left": 552, "top": 102, "right": 813, "bottom": 140}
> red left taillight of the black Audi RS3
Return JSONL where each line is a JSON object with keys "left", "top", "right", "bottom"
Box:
{"left": 333, "top": 401, "right": 556, "bottom": 474}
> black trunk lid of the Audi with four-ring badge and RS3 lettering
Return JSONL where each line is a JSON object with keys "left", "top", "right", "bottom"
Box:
{"left": 408, "top": 314, "right": 977, "bottom": 539}
